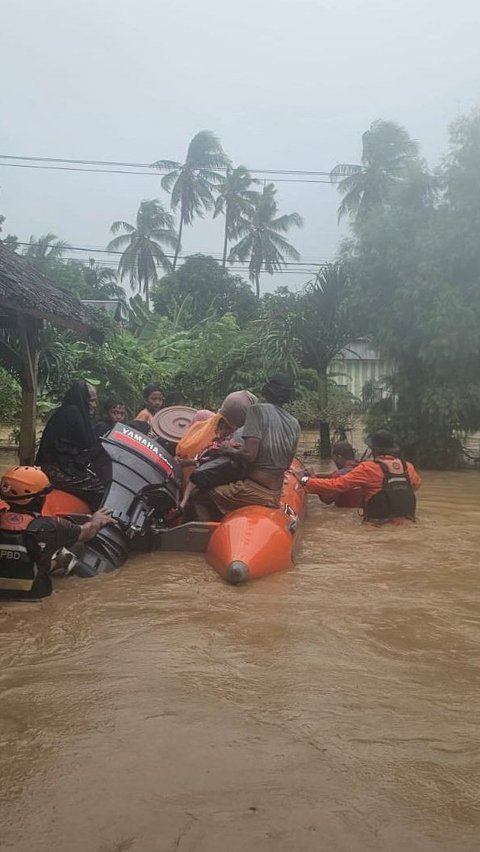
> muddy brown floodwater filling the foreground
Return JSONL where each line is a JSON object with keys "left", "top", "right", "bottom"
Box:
{"left": 0, "top": 472, "right": 480, "bottom": 852}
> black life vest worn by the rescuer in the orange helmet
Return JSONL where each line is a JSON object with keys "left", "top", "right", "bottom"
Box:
{"left": 0, "top": 511, "right": 42, "bottom": 594}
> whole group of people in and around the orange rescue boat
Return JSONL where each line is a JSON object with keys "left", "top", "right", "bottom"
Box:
{"left": 0, "top": 373, "right": 420, "bottom": 598}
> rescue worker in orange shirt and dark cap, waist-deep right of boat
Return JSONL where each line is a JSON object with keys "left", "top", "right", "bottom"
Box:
{"left": 300, "top": 429, "right": 421, "bottom": 523}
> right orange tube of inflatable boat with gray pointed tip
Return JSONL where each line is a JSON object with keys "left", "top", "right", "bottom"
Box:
{"left": 207, "top": 459, "right": 305, "bottom": 585}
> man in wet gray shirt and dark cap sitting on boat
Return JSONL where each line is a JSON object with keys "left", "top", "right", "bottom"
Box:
{"left": 194, "top": 373, "right": 300, "bottom": 520}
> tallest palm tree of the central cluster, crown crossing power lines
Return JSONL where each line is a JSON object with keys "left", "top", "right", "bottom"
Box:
{"left": 152, "top": 130, "right": 229, "bottom": 269}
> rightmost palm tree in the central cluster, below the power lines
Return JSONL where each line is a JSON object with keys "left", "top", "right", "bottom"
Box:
{"left": 228, "top": 183, "right": 303, "bottom": 298}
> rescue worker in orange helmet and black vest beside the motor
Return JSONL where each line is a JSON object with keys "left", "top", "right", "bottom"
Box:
{"left": 0, "top": 467, "right": 115, "bottom": 599}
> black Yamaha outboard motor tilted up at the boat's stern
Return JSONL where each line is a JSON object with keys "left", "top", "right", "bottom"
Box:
{"left": 72, "top": 423, "right": 182, "bottom": 577}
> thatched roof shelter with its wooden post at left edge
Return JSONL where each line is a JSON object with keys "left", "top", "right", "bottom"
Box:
{"left": 0, "top": 241, "right": 103, "bottom": 464}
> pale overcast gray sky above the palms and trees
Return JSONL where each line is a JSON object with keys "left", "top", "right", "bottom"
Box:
{"left": 0, "top": 0, "right": 480, "bottom": 289}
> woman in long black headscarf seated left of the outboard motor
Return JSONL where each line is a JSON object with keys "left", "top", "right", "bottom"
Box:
{"left": 35, "top": 381, "right": 104, "bottom": 509}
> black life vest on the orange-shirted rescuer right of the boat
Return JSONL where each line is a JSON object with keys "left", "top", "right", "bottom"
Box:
{"left": 363, "top": 458, "right": 417, "bottom": 521}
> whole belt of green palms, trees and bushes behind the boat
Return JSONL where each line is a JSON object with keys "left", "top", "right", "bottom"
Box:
{"left": 0, "top": 111, "right": 480, "bottom": 467}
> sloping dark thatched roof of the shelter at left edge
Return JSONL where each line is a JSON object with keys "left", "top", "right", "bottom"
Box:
{"left": 0, "top": 241, "right": 103, "bottom": 343}
